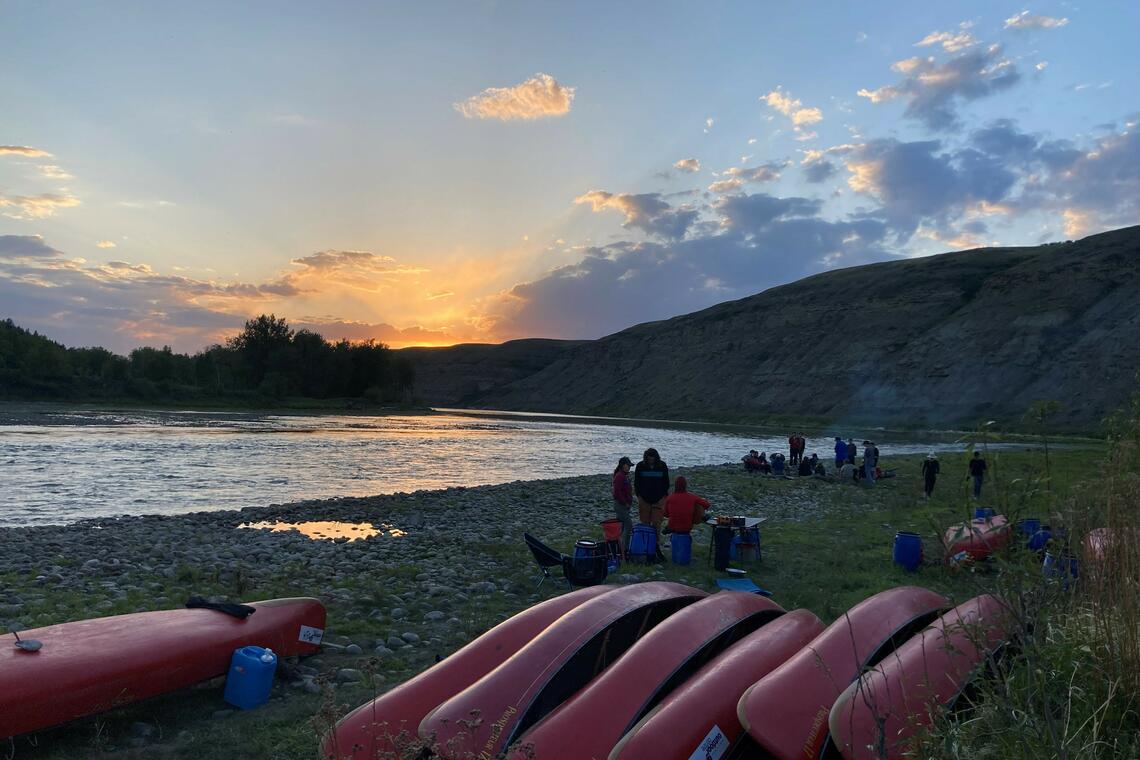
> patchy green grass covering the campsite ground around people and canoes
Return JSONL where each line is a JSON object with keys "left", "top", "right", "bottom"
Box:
{"left": 0, "top": 431, "right": 1140, "bottom": 760}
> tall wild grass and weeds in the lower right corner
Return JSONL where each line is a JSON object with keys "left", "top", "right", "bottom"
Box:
{"left": 912, "top": 407, "right": 1140, "bottom": 760}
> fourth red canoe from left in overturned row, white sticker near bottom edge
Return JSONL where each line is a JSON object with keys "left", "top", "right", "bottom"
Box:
{"left": 611, "top": 605, "right": 823, "bottom": 760}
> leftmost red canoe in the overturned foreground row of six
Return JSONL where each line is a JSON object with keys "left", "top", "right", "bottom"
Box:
{"left": 321, "top": 586, "right": 616, "bottom": 760}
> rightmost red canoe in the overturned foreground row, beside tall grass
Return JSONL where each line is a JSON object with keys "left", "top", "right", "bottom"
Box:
{"left": 829, "top": 595, "right": 1010, "bottom": 760}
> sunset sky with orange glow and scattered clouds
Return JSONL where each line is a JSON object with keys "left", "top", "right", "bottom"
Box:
{"left": 0, "top": 0, "right": 1140, "bottom": 353}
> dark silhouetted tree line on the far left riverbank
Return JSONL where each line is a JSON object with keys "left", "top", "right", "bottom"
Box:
{"left": 0, "top": 314, "right": 415, "bottom": 403}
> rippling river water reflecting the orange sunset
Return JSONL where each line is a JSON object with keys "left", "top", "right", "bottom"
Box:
{"left": 0, "top": 410, "right": 980, "bottom": 526}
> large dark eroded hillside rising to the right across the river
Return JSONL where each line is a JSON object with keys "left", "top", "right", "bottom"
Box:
{"left": 444, "top": 227, "right": 1140, "bottom": 430}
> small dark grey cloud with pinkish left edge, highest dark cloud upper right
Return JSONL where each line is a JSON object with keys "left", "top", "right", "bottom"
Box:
{"left": 858, "top": 44, "right": 1021, "bottom": 131}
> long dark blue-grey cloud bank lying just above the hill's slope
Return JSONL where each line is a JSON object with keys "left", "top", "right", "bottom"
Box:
{"left": 492, "top": 194, "right": 889, "bottom": 337}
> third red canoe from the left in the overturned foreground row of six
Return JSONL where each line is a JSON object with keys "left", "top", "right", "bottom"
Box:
{"left": 511, "top": 591, "right": 783, "bottom": 760}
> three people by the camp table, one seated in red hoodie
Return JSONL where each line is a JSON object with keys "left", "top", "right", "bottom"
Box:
{"left": 613, "top": 448, "right": 709, "bottom": 561}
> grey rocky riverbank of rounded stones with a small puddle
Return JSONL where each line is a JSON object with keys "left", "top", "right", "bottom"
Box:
{"left": 0, "top": 458, "right": 1044, "bottom": 759}
